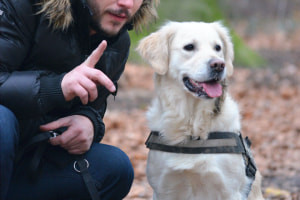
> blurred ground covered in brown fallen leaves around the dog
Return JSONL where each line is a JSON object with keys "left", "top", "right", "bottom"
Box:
{"left": 103, "top": 28, "right": 300, "bottom": 200}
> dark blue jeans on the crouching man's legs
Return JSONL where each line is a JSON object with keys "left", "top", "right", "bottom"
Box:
{"left": 0, "top": 106, "right": 133, "bottom": 200}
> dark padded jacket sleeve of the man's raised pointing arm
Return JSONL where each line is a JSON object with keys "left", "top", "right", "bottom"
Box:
{"left": 0, "top": 0, "right": 71, "bottom": 119}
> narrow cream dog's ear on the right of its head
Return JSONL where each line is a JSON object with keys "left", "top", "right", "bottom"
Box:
{"left": 213, "top": 22, "right": 234, "bottom": 76}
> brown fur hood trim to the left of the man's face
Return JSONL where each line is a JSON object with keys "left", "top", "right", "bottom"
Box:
{"left": 37, "top": 0, "right": 73, "bottom": 30}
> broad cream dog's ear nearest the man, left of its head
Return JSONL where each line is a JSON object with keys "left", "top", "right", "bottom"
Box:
{"left": 136, "top": 22, "right": 174, "bottom": 75}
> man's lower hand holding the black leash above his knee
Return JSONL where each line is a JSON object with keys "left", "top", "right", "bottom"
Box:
{"left": 40, "top": 115, "right": 94, "bottom": 154}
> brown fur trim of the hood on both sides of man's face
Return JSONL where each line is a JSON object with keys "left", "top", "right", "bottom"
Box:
{"left": 38, "top": 0, "right": 160, "bottom": 31}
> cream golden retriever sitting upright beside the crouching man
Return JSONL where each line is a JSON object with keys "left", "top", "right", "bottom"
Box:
{"left": 136, "top": 21, "right": 263, "bottom": 200}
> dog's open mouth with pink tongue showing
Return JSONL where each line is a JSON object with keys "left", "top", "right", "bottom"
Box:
{"left": 183, "top": 77, "right": 222, "bottom": 98}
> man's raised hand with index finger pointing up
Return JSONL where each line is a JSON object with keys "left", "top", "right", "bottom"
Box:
{"left": 61, "top": 40, "right": 116, "bottom": 104}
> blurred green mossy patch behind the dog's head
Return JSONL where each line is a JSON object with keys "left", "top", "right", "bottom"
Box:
{"left": 129, "top": 0, "right": 264, "bottom": 67}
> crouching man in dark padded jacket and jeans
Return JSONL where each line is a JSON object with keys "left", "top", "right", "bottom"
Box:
{"left": 0, "top": 0, "right": 158, "bottom": 200}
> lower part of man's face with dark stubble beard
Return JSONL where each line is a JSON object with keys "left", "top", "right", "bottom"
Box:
{"left": 87, "top": 0, "right": 143, "bottom": 36}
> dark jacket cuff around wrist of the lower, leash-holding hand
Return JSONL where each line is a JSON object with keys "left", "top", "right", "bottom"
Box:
{"left": 71, "top": 106, "right": 105, "bottom": 142}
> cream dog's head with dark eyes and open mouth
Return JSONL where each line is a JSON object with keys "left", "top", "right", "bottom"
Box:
{"left": 137, "top": 22, "right": 233, "bottom": 98}
